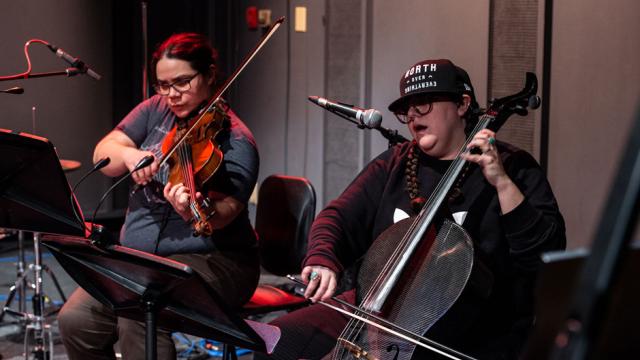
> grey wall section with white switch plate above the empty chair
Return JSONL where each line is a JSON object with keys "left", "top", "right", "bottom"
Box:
{"left": 229, "top": 0, "right": 327, "bottom": 202}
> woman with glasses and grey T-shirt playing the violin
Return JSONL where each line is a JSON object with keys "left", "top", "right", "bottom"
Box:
{"left": 58, "top": 33, "right": 260, "bottom": 360}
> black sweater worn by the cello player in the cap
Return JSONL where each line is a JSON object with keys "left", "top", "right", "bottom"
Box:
{"left": 304, "top": 142, "right": 566, "bottom": 358}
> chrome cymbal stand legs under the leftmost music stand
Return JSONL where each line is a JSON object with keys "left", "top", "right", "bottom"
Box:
{"left": 0, "top": 233, "right": 67, "bottom": 360}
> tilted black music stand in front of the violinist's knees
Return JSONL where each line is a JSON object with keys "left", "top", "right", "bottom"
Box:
{"left": 42, "top": 235, "right": 280, "bottom": 359}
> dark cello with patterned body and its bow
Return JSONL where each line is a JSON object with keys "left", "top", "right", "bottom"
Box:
{"left": 323, "top": 73, "right": 540, "bottom": 360}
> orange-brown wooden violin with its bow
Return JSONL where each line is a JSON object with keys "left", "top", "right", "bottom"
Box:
{"left": 151, "top": 17, "right": 284, "bottom": 236}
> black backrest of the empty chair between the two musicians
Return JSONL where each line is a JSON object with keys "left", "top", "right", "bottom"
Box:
{"left": 255, "top": 175, "right": 316, "bottom": 276}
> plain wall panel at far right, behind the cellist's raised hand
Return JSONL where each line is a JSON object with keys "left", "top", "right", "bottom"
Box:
{"left": 549, "top": 0, "right": 640, "bottom": 247}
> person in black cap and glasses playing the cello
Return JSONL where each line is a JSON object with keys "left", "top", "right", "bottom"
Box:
{"left": 256, "top": 60, "right": 566, "bottom": 359}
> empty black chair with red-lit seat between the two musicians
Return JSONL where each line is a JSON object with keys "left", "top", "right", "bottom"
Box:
{"left": 222, "top": 175, "right": 316, "bottom": 359}
